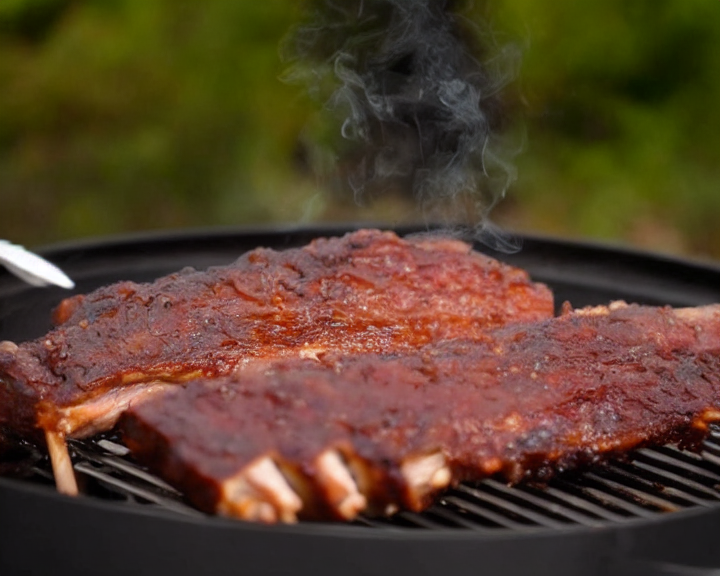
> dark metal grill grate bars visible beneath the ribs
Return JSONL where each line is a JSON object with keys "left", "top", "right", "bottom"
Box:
{"left": 9, "top": 428, "right": 720, "bottom": 531}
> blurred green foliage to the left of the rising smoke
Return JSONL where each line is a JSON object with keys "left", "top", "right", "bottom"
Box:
{"left": 0, "top": 0, "right": 318, "bottom": 243}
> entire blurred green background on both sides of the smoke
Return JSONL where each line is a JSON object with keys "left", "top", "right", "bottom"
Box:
{"left": 0, "top": 0, "right": 720, "bottom": 258}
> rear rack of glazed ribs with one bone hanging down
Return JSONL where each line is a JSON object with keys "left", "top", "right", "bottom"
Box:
{"left": 0, "top": 230, "right": 553, "bottom": 493}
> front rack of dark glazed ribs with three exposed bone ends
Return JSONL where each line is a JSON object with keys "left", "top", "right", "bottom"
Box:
{"left": 120, "top": 302, "right": 720, "bottom": 522}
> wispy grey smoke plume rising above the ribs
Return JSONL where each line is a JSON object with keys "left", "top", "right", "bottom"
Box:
{"left": 285, "top": 0, "right": 519, "bottom": 244}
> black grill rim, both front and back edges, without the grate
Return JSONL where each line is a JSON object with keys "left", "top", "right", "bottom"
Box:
{"left": 0, "top": 223, "right": 720, "bottom": 576}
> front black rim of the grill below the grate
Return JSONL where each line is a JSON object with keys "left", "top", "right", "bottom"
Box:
{"left": 0, "top": 478, "right": 720, "bottom": 576}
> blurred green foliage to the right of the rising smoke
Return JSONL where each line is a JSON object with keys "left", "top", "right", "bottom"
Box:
{"left": 496, "top": 0, "right": 720, "bottom": 257}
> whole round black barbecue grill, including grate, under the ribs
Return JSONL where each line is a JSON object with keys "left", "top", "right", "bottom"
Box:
{"left": 0, "top": 227, "right": 720, "bottom": 576}
